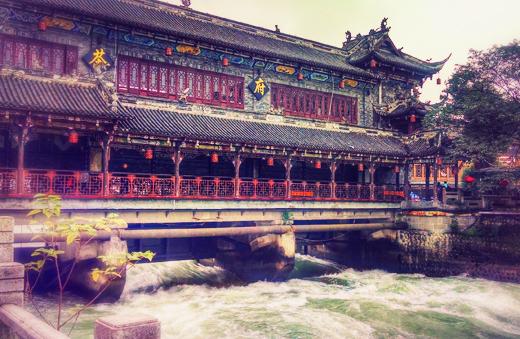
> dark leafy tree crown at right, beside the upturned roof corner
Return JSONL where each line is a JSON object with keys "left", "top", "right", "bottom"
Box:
{"left": 425, "top": 41, "right": 520, "bottom": 168}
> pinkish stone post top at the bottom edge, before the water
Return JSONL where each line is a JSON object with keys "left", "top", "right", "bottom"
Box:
{"left": 94, "top": 314, "right": 161, "bottom": 339}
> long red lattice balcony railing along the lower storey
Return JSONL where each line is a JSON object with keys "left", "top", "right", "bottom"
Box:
{"left": 0, "top": 169, "right": 404, "bottom": 202}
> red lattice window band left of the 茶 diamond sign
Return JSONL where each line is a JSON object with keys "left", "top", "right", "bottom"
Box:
{"left": 0, "top": 34, "right": 78, "bottom": 75}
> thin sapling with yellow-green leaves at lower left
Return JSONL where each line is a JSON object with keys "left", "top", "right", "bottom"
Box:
{"left": 25, "top": 194, "right": 155, "bottom": 334}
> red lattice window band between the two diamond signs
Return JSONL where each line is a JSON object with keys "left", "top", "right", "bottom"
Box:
{"left": 117, "top": 56, "right": 244, "bottom": 109}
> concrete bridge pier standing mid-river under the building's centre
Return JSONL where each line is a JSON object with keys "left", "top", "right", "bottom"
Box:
{"left": 215, "top": 221, "right": 296, "bottom": 282}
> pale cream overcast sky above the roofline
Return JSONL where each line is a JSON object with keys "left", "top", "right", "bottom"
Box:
{"left": 167, "top": 0, "right": 520, "bottom": 102}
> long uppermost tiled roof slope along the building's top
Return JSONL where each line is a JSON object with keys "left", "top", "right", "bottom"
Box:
{"left": 19, "top": 0, "right": 372, "bottom": 77}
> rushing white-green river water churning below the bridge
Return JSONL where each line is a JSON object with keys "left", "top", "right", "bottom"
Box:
{"left": 30, "top": 256, "right": 520, "bottom": 338}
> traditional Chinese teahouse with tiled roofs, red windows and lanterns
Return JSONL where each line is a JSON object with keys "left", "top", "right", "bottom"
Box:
{"left": 0, "top": 0, "right": 444, "bottom": 206}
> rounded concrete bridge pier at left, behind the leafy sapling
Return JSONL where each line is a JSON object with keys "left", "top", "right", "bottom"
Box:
{"left": 61, "top": 232, "right": 128, "bottom": 302}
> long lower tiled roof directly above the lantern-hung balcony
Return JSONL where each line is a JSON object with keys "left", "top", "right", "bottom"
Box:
{"left": 121, "top": 107, "right": 407, "bottom": 156}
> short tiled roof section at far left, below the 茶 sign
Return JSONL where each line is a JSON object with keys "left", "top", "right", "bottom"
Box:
{"left": 0, "top": 73, "right": 115, "bottom": 118}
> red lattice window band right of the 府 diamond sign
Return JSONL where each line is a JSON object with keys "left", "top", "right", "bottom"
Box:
{"left": 271, "top": 84, "right": 358, "bottom": 124}
